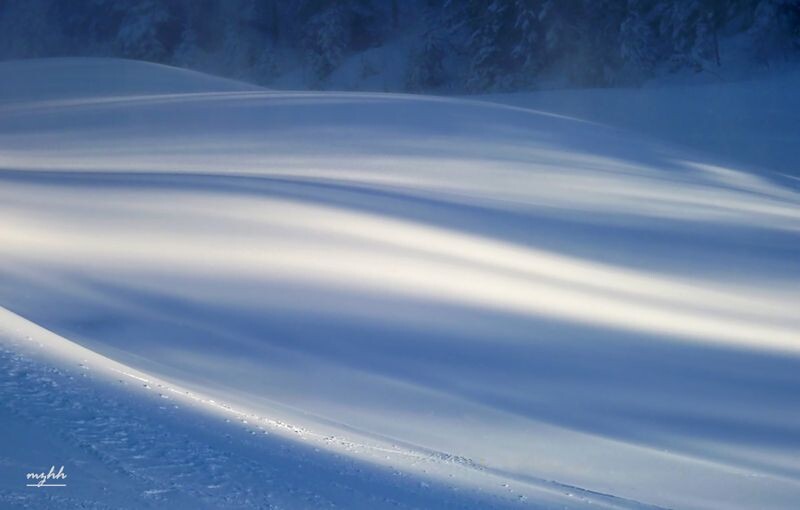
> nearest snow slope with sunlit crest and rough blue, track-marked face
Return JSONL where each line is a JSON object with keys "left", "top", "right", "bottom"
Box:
{"left": 0, "top": 309, "right": 592, "bottom": 510}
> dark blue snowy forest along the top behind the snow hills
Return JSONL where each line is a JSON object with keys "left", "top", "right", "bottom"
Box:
{"left": 0, "top": 0, "right": 800, "bottom": 92}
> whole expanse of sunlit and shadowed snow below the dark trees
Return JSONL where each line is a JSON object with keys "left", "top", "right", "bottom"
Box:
{"left": 0, "top": 59, "right": 800, "bottom": 509}
